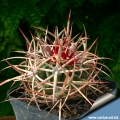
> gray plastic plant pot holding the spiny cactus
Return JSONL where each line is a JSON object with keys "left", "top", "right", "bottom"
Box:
{"left": 7, "top": 79, "right": 117, "bottom": 120}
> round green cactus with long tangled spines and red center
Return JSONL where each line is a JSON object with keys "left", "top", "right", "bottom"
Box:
{"left": 0, "top": 12, "right": 112, "bottom": 120}
